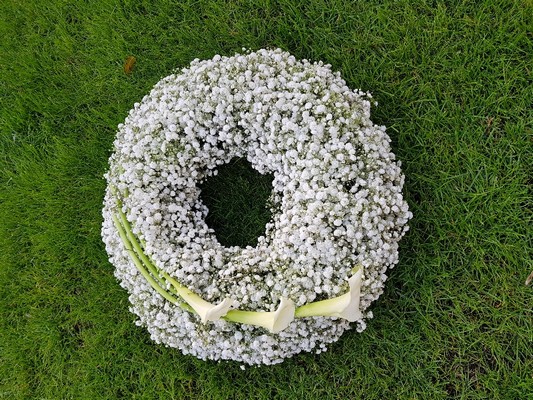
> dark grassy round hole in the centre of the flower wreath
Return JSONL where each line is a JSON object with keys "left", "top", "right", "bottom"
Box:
{"left": 199, "top": 158, "right": 273, "bottom": 247}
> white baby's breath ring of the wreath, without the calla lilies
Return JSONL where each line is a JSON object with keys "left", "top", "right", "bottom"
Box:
{"left": 102, "top": 49, "right": 411, "bottom": 364}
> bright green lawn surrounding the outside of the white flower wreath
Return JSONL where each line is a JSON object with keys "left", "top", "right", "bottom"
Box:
{"left": 0, "top": 0, "right": 533, "bottom": 399}
